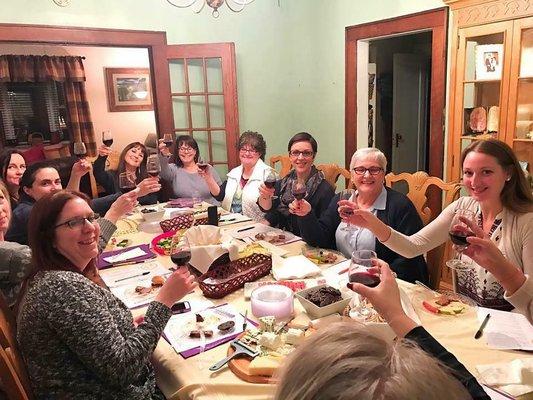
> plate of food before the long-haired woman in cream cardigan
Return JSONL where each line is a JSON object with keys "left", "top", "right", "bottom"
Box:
{"left": 418, "top": 290, "right": 477, "bottom": 317}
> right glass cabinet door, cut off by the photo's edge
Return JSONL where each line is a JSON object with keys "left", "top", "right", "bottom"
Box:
{"left": 507, "top": 18, "right": 533, "bottom": 189}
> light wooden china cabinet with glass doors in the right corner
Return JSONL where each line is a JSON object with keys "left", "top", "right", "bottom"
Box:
{"left": 444, "top": 0, "right": 533, "bottom": 180}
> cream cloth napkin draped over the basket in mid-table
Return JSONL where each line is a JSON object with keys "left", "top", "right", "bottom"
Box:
{"left": 185, "top": 225, "right": 239, "bottom": 274}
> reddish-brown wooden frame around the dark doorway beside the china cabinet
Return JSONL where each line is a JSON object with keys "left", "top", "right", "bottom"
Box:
{"left": 344, "top": 7, "right": 448, "bottom": 180}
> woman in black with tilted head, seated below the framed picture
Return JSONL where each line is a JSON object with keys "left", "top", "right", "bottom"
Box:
{"left": 93, "top": 142, "right": 161, "bottom": 205}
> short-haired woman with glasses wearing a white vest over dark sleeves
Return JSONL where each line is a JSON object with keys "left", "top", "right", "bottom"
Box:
{"left": 211, "top": 131, "right": 272, "bottom": 222}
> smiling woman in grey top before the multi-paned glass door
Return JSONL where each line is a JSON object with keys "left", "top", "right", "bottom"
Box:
{"left": 159, "top": 135, "right": 222, "bottom": 205}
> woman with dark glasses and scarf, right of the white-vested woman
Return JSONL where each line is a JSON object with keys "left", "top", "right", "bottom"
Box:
{"left": 257, "top": 132, "right": 335, "bottom": 235}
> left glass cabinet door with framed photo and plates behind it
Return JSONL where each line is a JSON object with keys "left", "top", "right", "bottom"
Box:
{"left": 451, "top": 22, "right": 513, "bottom": 180}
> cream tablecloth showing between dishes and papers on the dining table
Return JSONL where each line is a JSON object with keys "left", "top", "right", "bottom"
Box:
{"left": 104, "top": 206, "right": 533, "bottom": 400}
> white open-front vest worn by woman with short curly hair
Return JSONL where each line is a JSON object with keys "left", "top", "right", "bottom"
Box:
{"left": 222, "top": 159, "right": 271, "bottom": 221}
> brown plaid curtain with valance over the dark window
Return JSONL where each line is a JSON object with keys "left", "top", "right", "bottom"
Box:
{"left": 0, "top": 55, "right": 96, "bottom": 156}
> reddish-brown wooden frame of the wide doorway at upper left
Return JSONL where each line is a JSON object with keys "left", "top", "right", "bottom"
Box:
{"left": 0, "top": 24, "right": 168, "bottom": 141}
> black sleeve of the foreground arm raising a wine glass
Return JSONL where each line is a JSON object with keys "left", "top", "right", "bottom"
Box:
{"left": 405, "top": 326, "right": 490, "bottom": 400}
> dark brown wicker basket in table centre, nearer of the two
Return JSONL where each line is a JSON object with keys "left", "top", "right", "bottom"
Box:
{"left": 198, "top": 253, "right": 272, "bottom": 299}
